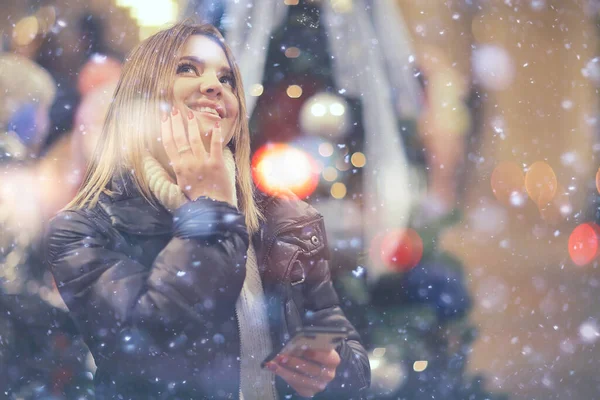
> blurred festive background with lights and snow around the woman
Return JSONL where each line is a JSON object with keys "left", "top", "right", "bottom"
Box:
{"left": 0, "top": 0, "right": 600, "bottom": 400}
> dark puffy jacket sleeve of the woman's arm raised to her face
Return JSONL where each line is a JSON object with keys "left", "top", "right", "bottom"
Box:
{"left": 46, "top": 199, "right": 248, "bottom": 376}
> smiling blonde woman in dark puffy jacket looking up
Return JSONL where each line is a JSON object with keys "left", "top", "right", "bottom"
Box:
{"left": 47, "top": 24, "right": 370, "bottom": 400}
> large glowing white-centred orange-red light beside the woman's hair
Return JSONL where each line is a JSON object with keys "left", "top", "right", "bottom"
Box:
{"left": 252, "top": 143, "right": 319, "bottom": 199}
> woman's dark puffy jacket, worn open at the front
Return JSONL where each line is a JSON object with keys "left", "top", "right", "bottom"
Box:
{"left": 46, "top": 178, "right": 370, "bottom": 399}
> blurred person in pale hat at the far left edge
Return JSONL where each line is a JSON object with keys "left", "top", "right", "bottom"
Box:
{"left": 0, "top": 54, "right": 90, "bottom": 399}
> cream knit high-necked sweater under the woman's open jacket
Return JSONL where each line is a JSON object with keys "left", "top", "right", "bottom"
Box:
{"left": 143, "top": 148, "right": 278, "bottom": 400}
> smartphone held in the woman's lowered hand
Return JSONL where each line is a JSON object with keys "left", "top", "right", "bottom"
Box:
{"left": 260, "top": 327, "right": 348, "bottom": 368}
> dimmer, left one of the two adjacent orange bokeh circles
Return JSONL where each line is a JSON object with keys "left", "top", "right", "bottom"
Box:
{"left": 490, "top": 161, "right": 526, "bottom": 206}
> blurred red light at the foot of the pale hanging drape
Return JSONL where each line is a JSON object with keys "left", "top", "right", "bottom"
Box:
{"left": 370, "top": 229, "right": 423, "bottom": 272}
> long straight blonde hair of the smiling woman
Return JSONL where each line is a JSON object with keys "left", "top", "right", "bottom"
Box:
{"left": 65, "top": 22, "right": 263, "bottom": 233}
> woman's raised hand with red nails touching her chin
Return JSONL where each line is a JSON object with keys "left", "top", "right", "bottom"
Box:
{"left": 161, "top": 108, "right": 234, "bottom": 205}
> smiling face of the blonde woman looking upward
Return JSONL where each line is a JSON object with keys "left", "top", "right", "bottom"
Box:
{"left": 173, "top": 35, "right": 239, "bottom": 151}
